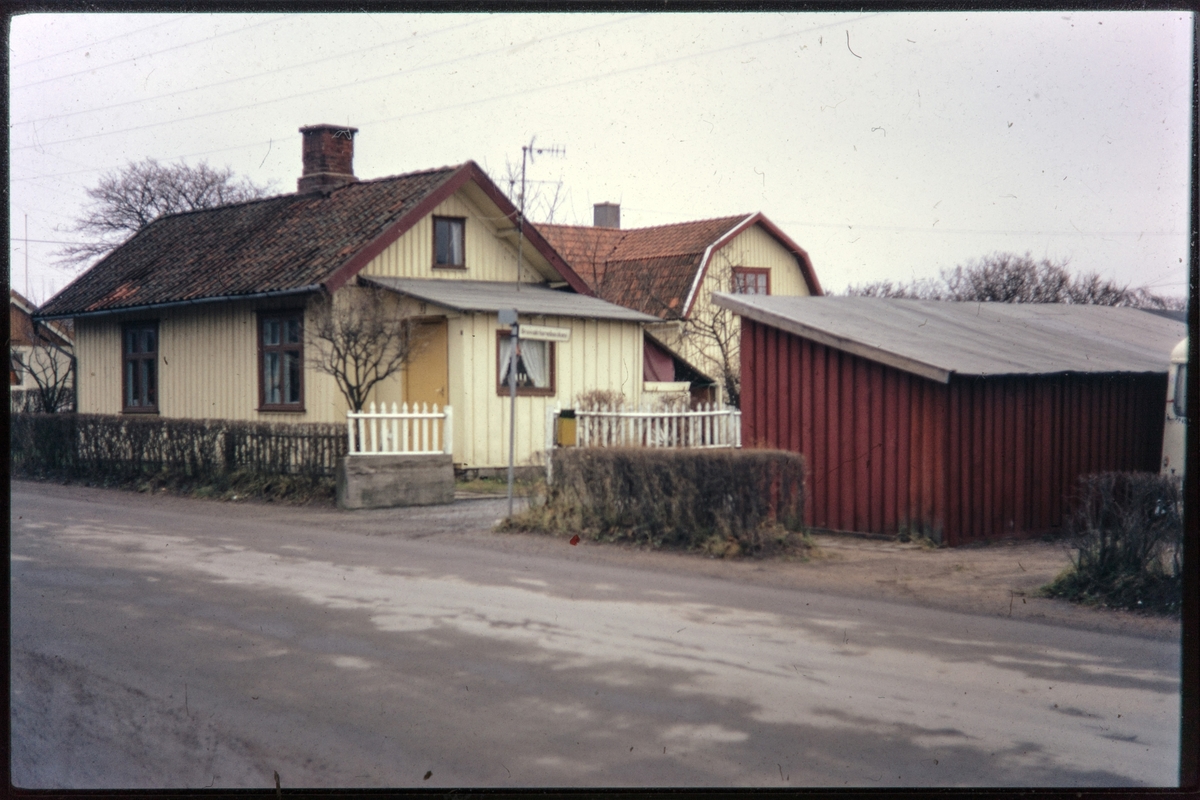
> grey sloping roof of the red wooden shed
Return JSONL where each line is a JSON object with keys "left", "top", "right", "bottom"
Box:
{"left": 713, "top": 294, "right": 1187, "bottom": 383}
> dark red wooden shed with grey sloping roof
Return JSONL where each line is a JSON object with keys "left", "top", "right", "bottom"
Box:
{"left": 714, "top": 295, "right": 1186, "bottom": 545}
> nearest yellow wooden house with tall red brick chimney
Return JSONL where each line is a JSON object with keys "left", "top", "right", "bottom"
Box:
{"left": 40, "top": 125, "right": 656, "bottom": 469}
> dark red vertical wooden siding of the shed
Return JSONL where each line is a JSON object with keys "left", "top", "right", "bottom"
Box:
{"left": 742, "top": 321, "right": 1166, "bottom": 545}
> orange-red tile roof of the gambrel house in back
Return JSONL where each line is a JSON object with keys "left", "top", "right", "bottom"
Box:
{"left": 536, "top": 219, "right": 750, "bottom": 319}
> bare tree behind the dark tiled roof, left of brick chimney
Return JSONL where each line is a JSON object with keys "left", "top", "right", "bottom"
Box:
{"left": 58, "top": 158, "right": 270, "bottom": 265}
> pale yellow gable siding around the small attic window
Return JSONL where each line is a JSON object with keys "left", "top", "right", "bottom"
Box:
{"left": 362, "top": 192, "right": 542, "bottom": 282}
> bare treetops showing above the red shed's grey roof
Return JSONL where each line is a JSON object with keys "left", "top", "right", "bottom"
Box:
{"left": 846, "top": 253, "right": 1187, "bottom": 309}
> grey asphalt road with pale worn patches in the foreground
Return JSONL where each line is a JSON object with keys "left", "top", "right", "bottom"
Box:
{"left": 11, "top": 482, "right": 1180, "bottom": 788}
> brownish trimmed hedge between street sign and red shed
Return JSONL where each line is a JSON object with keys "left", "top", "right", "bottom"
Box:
{"left": 508, "top": 447, "right": 805, "bottom": 555}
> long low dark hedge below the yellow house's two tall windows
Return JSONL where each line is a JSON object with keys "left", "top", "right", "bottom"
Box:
{"left": 10, "top": 414, "right": 347, "bottom": 483}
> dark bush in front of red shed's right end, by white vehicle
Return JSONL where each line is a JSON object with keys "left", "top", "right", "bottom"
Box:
{"left": 1042, "top": 473, "right": 1183, "bottom": 614}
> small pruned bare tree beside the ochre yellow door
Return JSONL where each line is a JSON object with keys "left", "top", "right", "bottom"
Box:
{"left": 307, "top": 287, "right": 421, "bottom": 411}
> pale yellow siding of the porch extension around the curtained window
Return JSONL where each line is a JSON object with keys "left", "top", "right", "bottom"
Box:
{"left": 449, "top": 314, "right": 642, "bottom": 468}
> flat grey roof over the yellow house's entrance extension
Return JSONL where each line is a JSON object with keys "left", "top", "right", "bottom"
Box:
{"left": 359, "top": 276, "right": 659, "bottom": 323}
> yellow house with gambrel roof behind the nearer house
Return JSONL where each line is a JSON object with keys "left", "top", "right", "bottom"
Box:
{"left": 538, "top": 203, "right": 822, "bottom": 403}
